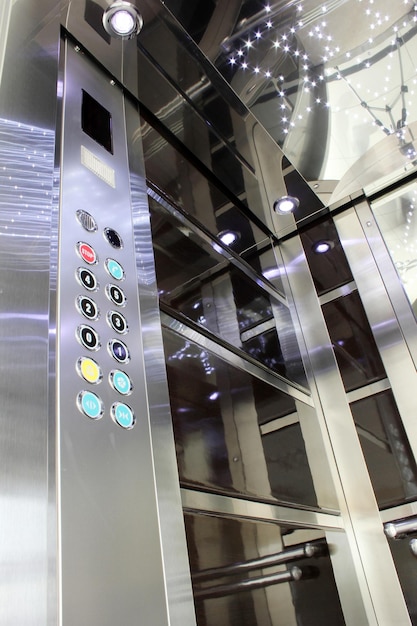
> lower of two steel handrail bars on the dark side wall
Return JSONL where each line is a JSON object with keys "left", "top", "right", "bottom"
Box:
{"left": 194, "top": 567, "right": 318, "bottom": 600}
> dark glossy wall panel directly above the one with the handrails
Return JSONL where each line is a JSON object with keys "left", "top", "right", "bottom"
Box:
{"left": 163, "top": 329, "right": 317, "bottom": 507}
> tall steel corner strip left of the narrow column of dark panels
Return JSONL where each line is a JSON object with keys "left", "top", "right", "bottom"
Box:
{"left": 281, "top": 237, "right": 410, "bottom": 624}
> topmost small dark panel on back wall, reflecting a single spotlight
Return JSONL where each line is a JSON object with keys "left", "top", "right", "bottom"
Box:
{"left": 300, "top": 217, "right": 353, "bottom": 296}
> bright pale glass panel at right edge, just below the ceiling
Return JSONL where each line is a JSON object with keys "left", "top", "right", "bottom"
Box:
{"left": 372, "top": 183, "right": 417, "bottom": 316}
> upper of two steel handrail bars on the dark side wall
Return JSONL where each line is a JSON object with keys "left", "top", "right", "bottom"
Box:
{"left": 193, "top": 539, "right": 327, "bottom": 583}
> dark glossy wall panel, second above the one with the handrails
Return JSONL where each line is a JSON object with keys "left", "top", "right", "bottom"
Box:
{"left": 150, "top": 198, "right": 307, "bottom": 386}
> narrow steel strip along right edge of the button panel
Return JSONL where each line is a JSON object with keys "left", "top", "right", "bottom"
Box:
{"left": 125, "top": 101, "right": 195, "bottom": 626}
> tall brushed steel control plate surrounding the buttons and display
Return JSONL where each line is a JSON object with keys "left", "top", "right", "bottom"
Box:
{"left": 58, "top": 44, "right": 169, "bottom": 626}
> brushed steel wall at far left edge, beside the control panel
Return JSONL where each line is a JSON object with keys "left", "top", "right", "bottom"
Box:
{"left": 0, "top": 0, "right": 59, "bottom": 626}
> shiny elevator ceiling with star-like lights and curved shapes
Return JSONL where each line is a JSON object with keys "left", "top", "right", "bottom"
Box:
{"left": 165, "top": 0, "right": 417, "bottom": 201}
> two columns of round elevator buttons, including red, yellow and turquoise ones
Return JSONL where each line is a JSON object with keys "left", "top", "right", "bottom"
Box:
{"left": 71, "top": 210, "right": 137, "bottom": 430}
